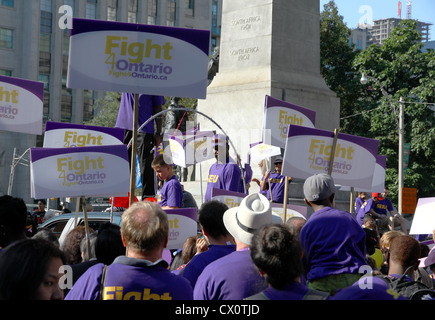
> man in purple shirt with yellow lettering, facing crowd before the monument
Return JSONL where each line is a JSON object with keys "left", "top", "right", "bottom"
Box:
{"left": 204, "top": 134, "right": 242, "bottom": 202}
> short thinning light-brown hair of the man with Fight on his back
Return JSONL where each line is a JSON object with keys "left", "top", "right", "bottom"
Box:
{"left": 121, "top": 201, "right": 169, "bottom": 252}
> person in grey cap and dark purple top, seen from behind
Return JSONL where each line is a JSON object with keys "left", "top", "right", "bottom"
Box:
{"left": 299, "top": 174, "right": 367, "bottom": 295}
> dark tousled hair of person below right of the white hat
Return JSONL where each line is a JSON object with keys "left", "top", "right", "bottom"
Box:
{"left": 250, "top": 224, "right": 303, "bottom": 290}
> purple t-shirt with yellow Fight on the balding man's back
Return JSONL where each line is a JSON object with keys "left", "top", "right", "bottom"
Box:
{"left": 65, "top": 256, "right": 193, "bottom": 300}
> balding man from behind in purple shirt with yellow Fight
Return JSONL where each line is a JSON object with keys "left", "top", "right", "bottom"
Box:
{"left": 65, "top": 201, "right": 193, "bottom": 300}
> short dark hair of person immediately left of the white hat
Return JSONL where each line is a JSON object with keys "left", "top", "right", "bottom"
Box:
{"left": 198, "top": 200, "right": 228, "bottom": 238}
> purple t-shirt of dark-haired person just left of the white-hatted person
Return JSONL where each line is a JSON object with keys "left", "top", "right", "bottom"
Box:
{"left": 182, "top": 245, "right": 236, "bottom": 287}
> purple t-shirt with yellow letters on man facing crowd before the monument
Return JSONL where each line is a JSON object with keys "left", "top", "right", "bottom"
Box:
{"left": 204, "top": 162, "right": 242, "bottom": 201}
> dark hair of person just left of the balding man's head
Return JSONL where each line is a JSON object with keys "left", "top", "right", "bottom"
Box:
{"left": 95, "top": 222, "right": 125, "bottom": 264}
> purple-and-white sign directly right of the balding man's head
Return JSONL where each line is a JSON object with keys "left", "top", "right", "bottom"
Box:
{"left": 164, "top": 208, "right": 198, "bottom": 250}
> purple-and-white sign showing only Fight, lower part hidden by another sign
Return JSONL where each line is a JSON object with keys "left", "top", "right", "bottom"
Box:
{"left": 44, "top": 121, "right": 124, "bottom": 148}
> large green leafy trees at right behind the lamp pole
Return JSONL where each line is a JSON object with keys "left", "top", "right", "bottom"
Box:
{"left": 321, "top": 6, "right": 435, "bottom": 206}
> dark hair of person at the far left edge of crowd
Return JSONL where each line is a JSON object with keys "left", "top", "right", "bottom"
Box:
{"left": 0, "top": 195, "right": 27, "bottom": 247}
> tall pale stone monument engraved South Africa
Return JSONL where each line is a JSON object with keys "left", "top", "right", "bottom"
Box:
{"left": 198, "top": 0, "right": 340, "bottom": 146}
